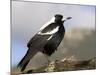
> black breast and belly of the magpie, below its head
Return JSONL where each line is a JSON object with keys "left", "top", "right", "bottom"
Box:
{"left": 43, "top": 25, "right": 65, "bottom": 56}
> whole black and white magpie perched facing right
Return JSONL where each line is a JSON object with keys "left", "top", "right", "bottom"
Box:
{"left": 18, "top": 14, "right": 71, "bottom": 71}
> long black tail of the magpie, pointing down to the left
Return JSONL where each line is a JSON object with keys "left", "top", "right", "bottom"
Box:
{"left": 17, "top": 50, "right": 36, "bottom": 72}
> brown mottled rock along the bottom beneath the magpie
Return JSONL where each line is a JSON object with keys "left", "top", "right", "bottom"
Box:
{"left": 25, "top": 57, "right": 96, "bottom": 73}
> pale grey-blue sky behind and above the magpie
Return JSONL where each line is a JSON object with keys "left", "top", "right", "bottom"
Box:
{"left": 12, "top": 1, "right": 95, "bottom": 65}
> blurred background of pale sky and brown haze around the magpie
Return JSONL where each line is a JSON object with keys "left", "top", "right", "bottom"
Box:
{"left": 11, "top": 1, "right": 96, "bottom": 70}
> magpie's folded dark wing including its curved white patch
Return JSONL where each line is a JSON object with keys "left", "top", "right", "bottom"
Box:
{"left": 27, "top": 23, "right": 59, "bottom": 47}
